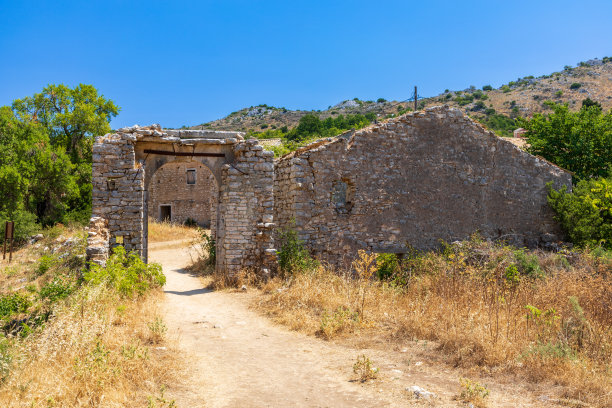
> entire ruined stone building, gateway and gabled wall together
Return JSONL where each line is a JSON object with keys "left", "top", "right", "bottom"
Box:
{"left": 88, "top": 107, "right": 571, "bottom": 273}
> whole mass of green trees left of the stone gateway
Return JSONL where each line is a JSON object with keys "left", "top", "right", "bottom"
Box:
{"left": 0, "top": 84, "right": 119, "bottom": 231}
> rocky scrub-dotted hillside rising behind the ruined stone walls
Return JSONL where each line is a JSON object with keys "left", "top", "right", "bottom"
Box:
{"left": 192, "top": 57, "right": 612, "bottom": 135}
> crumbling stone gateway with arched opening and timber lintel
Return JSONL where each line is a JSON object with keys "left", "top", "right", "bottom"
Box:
{"left": 88, "top": 125, "right": 275, "bottom": 273}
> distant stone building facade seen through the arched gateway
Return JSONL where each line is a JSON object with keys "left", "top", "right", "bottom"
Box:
{"left": 148, "top": 162, "right": 218, "bottom": 228}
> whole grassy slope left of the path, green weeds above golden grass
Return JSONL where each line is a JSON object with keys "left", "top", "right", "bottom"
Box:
{"left": 0, "top": 226, "right": 179, "bottom": 407}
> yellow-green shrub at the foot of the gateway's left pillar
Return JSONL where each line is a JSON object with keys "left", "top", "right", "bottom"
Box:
{"left": 83, "top": 246, "right": 166, "bottom": 297}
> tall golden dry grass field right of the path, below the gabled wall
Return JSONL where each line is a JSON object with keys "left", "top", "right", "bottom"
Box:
{"left": 251, "top": 241, "right": 612, "bottom": 407}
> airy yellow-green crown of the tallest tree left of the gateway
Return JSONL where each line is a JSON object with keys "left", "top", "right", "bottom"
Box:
{"left": 13, "top": 84, "right": 119, "bottom": 161}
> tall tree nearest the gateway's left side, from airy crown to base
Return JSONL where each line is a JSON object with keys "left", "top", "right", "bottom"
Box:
{"left": 12, "top": 84, "right": 119, "bottom": 223}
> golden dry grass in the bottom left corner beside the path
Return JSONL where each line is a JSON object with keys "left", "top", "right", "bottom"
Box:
{"left": 0, "top": 286, "right": 177, "bottom": 407}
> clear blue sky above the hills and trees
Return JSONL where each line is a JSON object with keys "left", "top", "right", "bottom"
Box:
{"left": 0, "top": 0, "right": 612, "bottom": 128}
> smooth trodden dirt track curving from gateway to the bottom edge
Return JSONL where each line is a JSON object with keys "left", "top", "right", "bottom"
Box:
{"left": 150, "top": 242, "right": 391, "bottom": 408}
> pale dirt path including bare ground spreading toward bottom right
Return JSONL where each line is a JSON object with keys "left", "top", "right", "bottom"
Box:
{"left": 150, "top": 243, "right": 560, "bottom": 408}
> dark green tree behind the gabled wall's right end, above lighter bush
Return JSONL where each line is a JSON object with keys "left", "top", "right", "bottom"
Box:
{"left": 517, "top": 102, "right": 612, "bottom": 179}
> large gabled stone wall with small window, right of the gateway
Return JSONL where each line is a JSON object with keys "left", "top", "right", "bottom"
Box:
{"left": 274, "top": 107, "right": 571, "bottom": 263}
